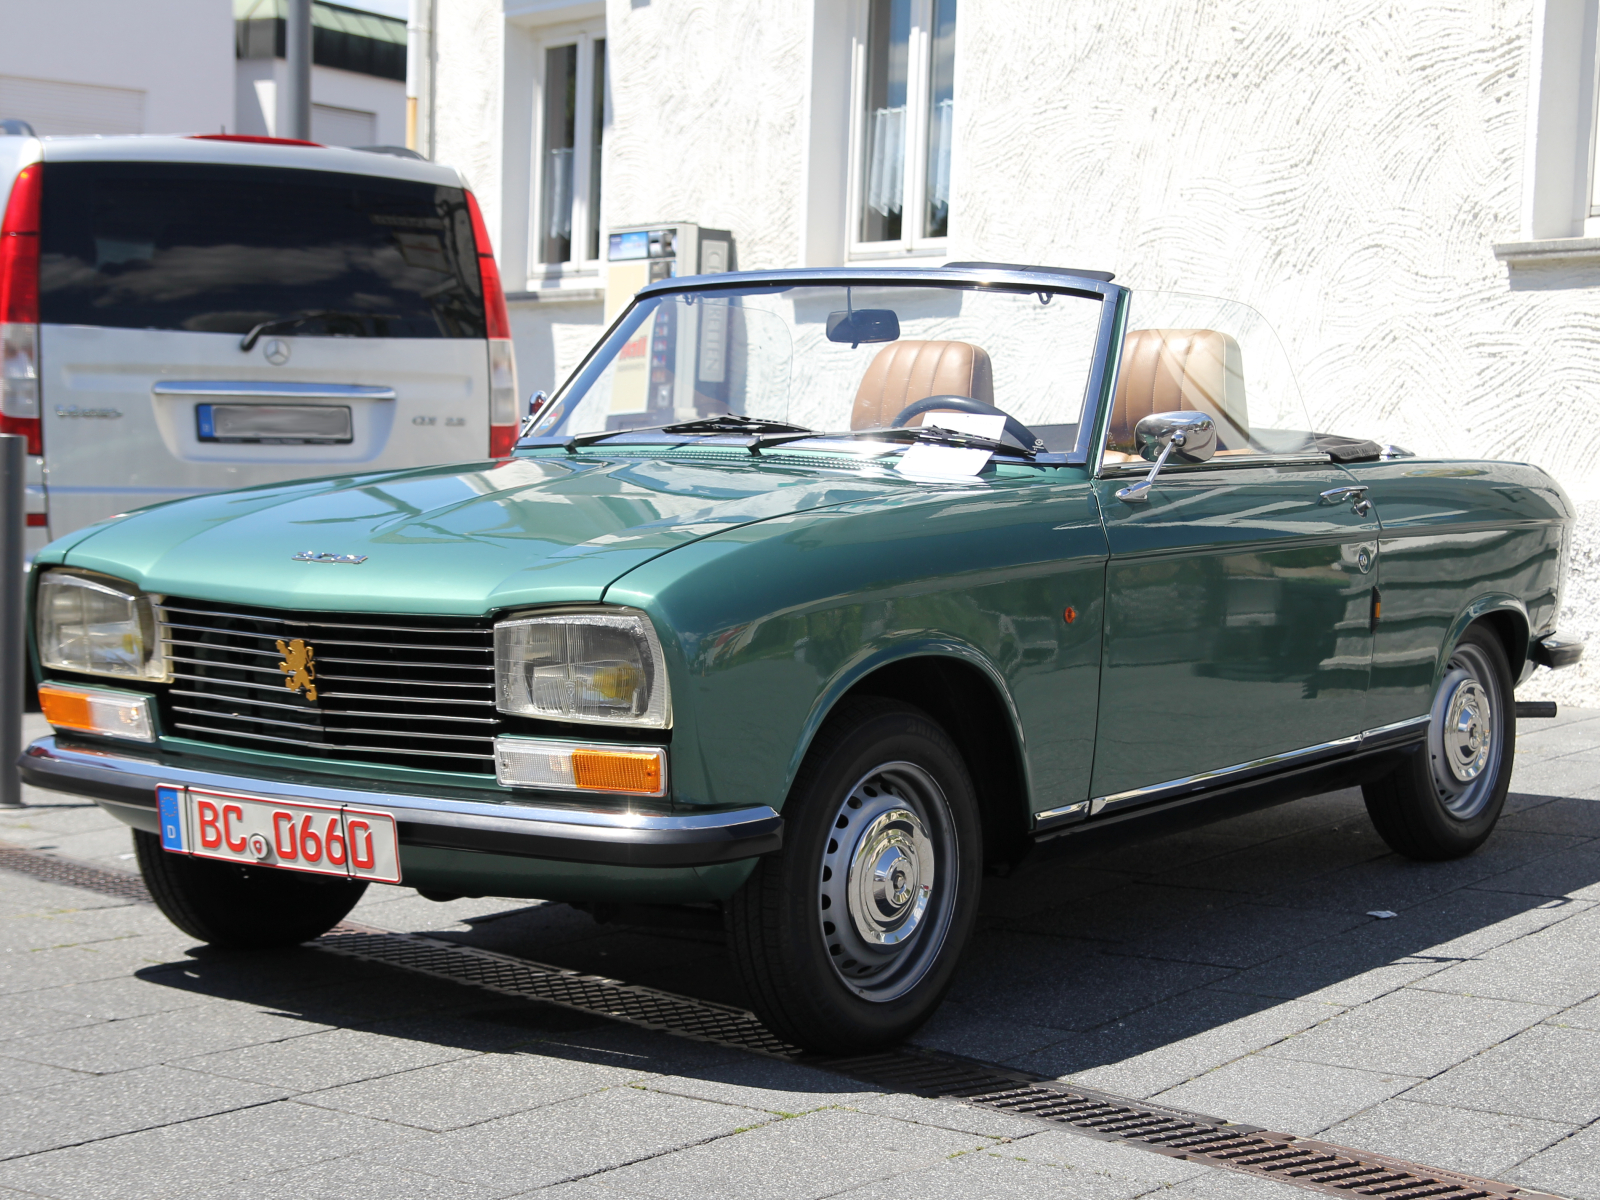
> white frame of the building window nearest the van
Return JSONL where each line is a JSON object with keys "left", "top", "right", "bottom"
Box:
{"left": 528, "top": 19, "right": 610, "bottom": 283}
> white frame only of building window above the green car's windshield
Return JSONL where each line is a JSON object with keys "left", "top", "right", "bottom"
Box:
{"left": 846, "top": 0, "right": 962, "bottom": 259}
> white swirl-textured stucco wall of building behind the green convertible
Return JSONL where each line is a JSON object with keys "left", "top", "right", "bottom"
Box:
{"left": 438, "top": 0, "right": 1600, "bottom": 704}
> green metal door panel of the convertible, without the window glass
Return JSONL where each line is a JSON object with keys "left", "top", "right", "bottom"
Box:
{"left": 1093, "top": 462, "right": 1378, "bottom": 803}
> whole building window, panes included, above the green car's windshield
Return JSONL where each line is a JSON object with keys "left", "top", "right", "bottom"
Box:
{"left": 853, "top": 0, "right": 957, "bottom": 253}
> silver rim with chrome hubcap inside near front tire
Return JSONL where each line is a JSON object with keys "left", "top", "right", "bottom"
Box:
{"left": 818, "top": 762, "right": 955, "bottom": 1002}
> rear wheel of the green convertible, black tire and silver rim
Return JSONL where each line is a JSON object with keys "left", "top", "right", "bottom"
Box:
{"left": 1362, "top": 626, "right": 1517, "bottom": 862}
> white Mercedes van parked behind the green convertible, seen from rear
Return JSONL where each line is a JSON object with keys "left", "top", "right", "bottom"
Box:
{"left": 0, "top": 134, "right": 517, "bottom": 558}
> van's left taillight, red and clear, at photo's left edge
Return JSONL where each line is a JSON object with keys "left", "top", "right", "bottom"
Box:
{"left": 0, "top": 163, "right": 45, "bottom": 454}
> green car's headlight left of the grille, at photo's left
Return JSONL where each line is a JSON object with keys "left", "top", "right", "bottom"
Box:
{"left": 37, "top": 571, "right": 170, "bottom": 682}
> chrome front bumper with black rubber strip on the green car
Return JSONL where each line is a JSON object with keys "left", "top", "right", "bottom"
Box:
{"left": 18, "top": 738, "right": 784, "bottom": 867}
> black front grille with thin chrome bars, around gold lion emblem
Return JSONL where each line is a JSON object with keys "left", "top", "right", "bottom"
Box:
{"left": 157, "top": 597, "right": 501, "bottom": 774}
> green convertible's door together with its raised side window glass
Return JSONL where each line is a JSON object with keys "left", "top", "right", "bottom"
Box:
{"left": 1091, "top": 307, "right": 1379, "bottom": 811}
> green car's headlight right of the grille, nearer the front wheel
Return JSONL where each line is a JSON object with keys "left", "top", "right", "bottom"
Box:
{"left": 494, "top": 608, "right": 672, "bottom": 730}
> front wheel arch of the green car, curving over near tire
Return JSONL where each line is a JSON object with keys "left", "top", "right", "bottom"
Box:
{"left": 789, "top": 642, "right": 1032, "bottom": 862}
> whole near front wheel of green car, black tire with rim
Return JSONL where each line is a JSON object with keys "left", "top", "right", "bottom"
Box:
{"left": 726, "top": 698, "right": 984, "bottom": 1054}
